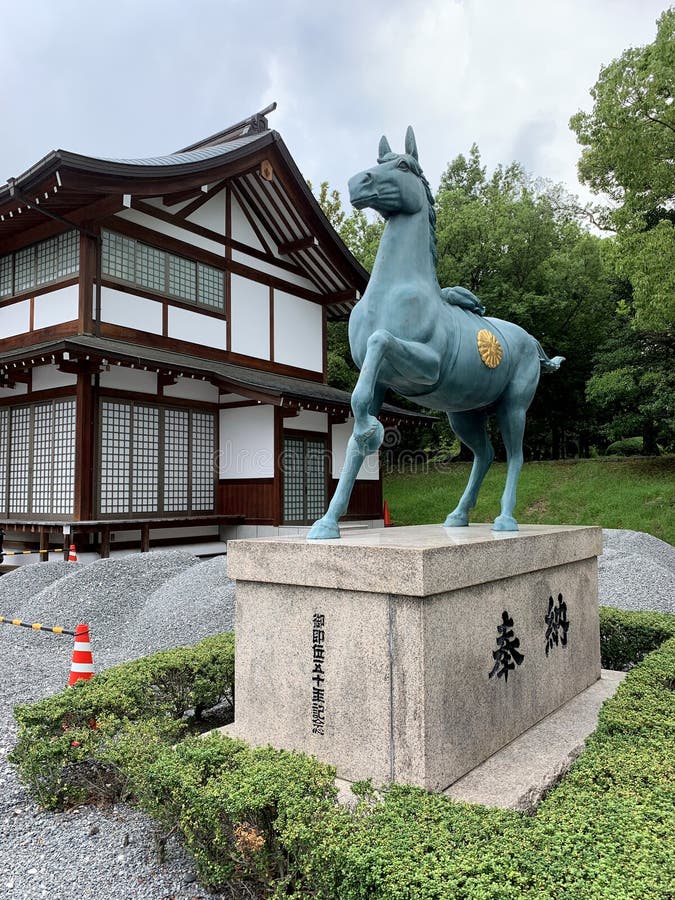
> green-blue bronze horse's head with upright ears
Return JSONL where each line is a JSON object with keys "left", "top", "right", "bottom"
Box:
{"left": 349, "top": 126, "right": 428, "bottom": 219}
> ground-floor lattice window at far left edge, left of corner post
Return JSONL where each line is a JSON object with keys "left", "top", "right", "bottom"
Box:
{"left": 0, "top": 400, "right": 75, "bottom": 517}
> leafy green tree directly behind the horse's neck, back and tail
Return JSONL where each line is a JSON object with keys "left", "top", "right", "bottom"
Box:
{"left": 437, "top": 145, "right": 613, "bottom": 458}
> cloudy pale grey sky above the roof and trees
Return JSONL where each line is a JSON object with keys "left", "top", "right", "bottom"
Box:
{"left": 0, "top": 0, "right": 669, "bottom": 207}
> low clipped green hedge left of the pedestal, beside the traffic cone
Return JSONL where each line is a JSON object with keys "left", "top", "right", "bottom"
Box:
{"left": 10, "top": 634, "right": 234, "bottom": 809}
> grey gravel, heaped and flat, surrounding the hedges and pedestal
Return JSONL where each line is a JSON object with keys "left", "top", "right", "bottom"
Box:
{"left": 0, "top": 531, "right": 675, "bottom": 900}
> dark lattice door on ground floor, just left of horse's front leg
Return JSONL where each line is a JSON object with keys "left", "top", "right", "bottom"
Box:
{"left": 283, "top": 435, "right": 326, "bottom": 524}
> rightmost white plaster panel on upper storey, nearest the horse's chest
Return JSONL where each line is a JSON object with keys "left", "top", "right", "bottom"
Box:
{"left": 274, "top": 290, "right": 323, "bottom": 372}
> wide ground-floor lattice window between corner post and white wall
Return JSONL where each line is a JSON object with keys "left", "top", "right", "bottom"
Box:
{"left": 99, "top": 400, "right": 215, "bottom": 516}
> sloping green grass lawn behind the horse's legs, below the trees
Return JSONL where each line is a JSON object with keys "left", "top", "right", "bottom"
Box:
{"left": 384, "top": 456, "right": 675, "bottom": 544}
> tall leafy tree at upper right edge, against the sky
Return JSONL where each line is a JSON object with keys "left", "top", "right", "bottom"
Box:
{"left": 570, "top": 8, "right": 675, "bottom": 330}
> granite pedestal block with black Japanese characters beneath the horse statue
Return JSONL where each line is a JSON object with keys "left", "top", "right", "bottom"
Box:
{"left": 228, "top": 525, "right": 602, "bottom": 790}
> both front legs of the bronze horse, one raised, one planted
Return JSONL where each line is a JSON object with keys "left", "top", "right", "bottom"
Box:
{"left": 307, "top": 330, "right": 440, "bottom": 541}
